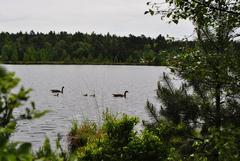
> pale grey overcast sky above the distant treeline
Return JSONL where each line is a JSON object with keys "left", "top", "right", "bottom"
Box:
{"left": 0, "top": 0, "right": 193, "bottom": 38}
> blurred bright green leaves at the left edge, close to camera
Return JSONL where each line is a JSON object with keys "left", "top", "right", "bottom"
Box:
{"left": 0, "top": 67, "right": 50, "bottom": 161}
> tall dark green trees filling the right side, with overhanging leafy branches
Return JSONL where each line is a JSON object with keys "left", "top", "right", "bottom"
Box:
{"left": 143, "top": 0, "right": 240, "bottom": 161}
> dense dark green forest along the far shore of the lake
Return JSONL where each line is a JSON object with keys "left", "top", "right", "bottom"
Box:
{"left": 0, "top": 31, "right": 195, "bottom": 65}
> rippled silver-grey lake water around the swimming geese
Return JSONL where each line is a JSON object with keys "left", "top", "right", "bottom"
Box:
{"left": 4, "top": 65, "right": 180, "bottom": 149}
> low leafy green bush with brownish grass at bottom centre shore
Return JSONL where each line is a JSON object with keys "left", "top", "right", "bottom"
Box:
{"left": 67, "top": 113, "right": 168, "bottom": 161}
